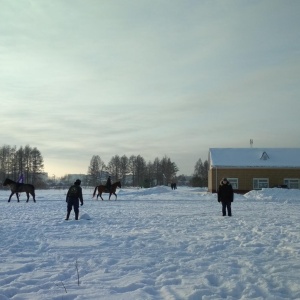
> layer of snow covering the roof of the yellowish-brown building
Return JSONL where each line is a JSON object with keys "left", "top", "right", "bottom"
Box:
{"left": 209, "top": 148, "right": 300, "bottom": 168}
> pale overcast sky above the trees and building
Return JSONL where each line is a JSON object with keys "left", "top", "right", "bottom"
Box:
{"left": 0, "top": 0, "right": 300, "bottom": 176}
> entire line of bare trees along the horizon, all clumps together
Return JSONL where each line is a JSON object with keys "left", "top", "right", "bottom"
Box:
{"left": 0, "top": 145, "right": 209, "bottom": 187}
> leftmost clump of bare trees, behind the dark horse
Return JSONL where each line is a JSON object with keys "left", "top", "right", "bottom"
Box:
{"left": 0, "top": 145, "right": 44, "bottom": 185}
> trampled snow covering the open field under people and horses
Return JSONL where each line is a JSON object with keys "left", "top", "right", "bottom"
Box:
{"left": 0, "top": 187, "right": 300, "bottom": 300}
